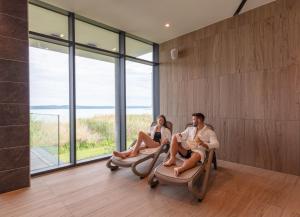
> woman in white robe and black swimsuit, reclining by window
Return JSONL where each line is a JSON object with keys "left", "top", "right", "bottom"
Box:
{"left": 113, "top": 115, "right": 171, "bottom": 159}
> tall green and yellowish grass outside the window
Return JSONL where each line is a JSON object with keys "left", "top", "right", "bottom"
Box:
{"left": 30, "top": 114, "right": 152, "bottom": 164}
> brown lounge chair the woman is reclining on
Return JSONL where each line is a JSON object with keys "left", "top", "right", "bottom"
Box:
{"left": 106, "top": 121, "right": 173, "bottom": 178}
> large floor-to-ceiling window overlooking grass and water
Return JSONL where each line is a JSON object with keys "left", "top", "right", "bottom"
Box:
{"left": 29, "top": 1, "right": 157, "bottom": 173}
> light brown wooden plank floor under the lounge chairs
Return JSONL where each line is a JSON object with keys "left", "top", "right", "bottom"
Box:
{"left": 0, "top": 161, "right": 300, "bottom": 217}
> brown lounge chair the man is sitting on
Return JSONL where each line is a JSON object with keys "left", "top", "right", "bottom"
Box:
{"left": 148, "top": 124, "right": 217, "bottom": 201}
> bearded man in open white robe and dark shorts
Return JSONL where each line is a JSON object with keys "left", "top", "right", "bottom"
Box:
{"left": 164, "top": 113, "right": 219, "bottom": 176}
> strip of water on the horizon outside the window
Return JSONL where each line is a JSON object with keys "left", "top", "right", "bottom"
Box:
{"left": 30, "top": 108, "right": 152, "bottom": 122}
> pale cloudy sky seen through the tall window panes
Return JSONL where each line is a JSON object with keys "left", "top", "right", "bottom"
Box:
{"left": 29, "top": 47, "right": 152, "bottom": 106}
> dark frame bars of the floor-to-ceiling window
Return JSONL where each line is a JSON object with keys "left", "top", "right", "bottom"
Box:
{"left": 28, "top": 0, "right": 160, "bottom": 176}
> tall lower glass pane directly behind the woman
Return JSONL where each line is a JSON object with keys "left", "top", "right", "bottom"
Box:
{"left": 126, "top": 61, "right": 153, "bottom": 147}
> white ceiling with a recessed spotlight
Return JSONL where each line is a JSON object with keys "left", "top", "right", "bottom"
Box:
{"left": 43, "top": 0, "right": 274, "bottom": 43}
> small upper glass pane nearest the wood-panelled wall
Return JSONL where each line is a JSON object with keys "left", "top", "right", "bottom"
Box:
{"left": 126, "top": 37, "right": 153, "bottom": 61}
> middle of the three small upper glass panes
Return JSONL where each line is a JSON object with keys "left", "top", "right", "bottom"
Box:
{"left": 75, "top": 20, "right": 119, "bottom": 52}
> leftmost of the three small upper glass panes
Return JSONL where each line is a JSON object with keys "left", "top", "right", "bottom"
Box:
{"left": 28, "top": 4, "right": 68, "bottom": 39}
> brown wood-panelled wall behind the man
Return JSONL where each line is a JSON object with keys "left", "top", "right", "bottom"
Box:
{"left": 160, "top": 0, "right": 300, "bottom": 175}
